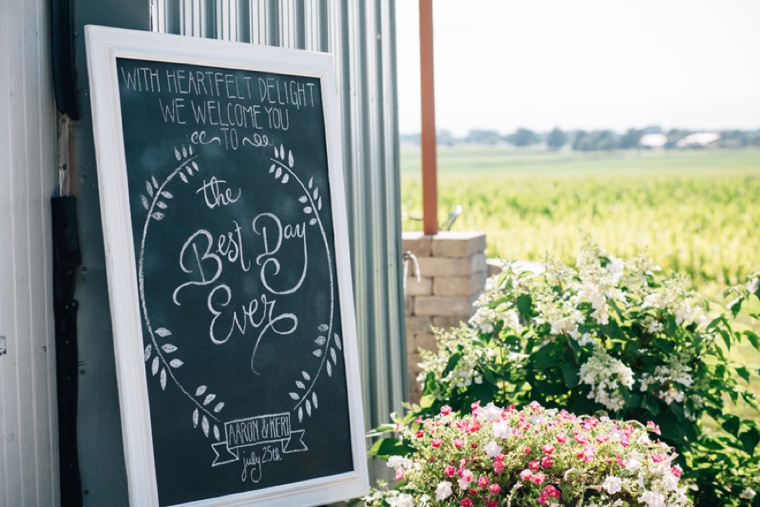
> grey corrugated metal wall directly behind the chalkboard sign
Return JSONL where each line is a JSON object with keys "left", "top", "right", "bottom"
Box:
{"left": 153, "top": 0, "right": 408, "bottom": 425}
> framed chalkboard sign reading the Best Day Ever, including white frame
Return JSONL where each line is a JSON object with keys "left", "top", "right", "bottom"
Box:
{"left": 86, "top": 26, "right": 368, "bottom": 506}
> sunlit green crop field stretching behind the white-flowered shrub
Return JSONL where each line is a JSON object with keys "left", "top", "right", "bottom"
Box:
{"left": 401, "top": 146, "right": 760, "bottom": 298}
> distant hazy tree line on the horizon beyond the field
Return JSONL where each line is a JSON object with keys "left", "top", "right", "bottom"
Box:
{"left": 400, "top": 126, "right": 760, "bottom": 151}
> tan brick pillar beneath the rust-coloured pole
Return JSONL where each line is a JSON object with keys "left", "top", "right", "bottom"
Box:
{"left": 402, "top": 231, "right": 487, "bottom": 402}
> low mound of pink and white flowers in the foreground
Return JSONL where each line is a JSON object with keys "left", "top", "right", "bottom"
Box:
{"left": 365, "top": 402, "right": 690, "bottom": 507}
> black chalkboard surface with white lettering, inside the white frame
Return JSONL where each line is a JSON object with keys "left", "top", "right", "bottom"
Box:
{"left": 84, "top": 26, "right": 363, "bottom": 505}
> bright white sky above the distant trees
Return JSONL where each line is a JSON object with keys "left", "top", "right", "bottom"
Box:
{"left": 396, "top": 0, "right": 760, "bottom": 135}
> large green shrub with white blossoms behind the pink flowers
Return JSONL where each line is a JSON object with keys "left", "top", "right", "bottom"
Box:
{"left": 400, "top": 241, "right": 760, "bottom": 506}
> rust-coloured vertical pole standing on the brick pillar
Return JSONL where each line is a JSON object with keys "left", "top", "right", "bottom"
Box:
{"left": 420, "top": 0, "right": 438, "bottom": 235}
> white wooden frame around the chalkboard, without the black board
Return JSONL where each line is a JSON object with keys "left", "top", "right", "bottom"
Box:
{"left": 85, "top": 25, "right": 369, "bottom": 507}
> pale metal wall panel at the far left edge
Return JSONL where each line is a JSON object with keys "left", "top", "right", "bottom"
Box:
{"left": 0, "top": 0, "right": 58, "bottom": 507}
